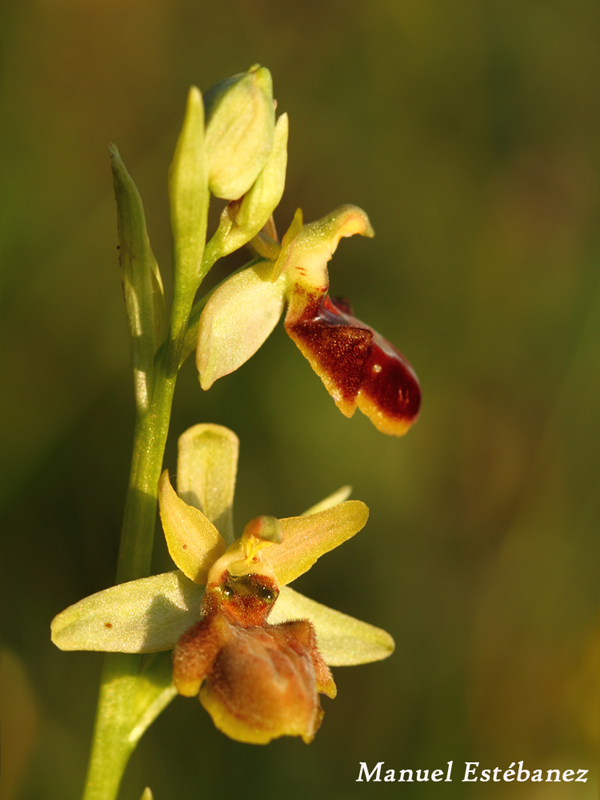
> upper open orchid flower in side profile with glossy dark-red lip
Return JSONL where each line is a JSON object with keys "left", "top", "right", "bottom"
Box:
{"left": 196, "top": 205, "right": 421, "bottom": 436}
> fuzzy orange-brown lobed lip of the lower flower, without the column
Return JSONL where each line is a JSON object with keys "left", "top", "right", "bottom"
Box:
{"left": 173, "top": 580, "right": 336, "bottom": 744}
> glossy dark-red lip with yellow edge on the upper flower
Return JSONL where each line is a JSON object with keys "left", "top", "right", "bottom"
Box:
{"left": 286, "top": 290, "right": 421, "bottom": 436}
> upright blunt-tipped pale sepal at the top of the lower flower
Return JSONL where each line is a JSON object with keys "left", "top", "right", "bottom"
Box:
{"left": 177, "top": 424, "right": 240, "bottom": 544}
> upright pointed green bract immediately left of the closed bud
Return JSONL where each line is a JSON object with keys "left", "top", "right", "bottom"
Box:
{"left": 169, "top": 86, "right": 209, "bottom": 294}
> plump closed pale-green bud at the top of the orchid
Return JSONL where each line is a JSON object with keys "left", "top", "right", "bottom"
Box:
{"left": 204, "top": 65, "right": 275, "bottom": 200}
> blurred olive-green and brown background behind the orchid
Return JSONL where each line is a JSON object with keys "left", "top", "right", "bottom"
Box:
{"left": 0, "top": 0, "right": 600, "bottom": 800}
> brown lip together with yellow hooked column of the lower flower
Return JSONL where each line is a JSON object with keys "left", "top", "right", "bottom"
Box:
{"left": 173, "top": 517, "right": 336, "bottom": 744}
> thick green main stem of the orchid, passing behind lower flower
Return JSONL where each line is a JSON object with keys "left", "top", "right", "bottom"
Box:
{"left": 83, "top": 288, "right": 194, "bottom": 800}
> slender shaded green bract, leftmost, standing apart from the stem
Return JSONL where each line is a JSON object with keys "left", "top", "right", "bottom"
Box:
{"left": 109, "top": 144, "right": 167, "bottom": 411}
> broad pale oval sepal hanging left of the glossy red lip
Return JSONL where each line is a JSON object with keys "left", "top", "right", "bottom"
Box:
{"left": 196, "top": 261, "right": 284, "bottom": 390}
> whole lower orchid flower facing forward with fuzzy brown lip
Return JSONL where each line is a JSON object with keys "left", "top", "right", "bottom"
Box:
{"left": 52, "top": 425, "right": 394, "bottom": 744}
